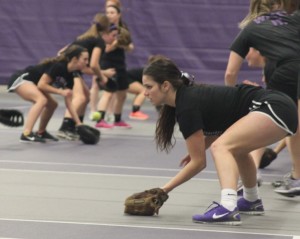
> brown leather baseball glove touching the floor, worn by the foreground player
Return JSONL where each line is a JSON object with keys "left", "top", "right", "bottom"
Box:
{"left": 124, "top": 188, "right": 169, "bottom": 216}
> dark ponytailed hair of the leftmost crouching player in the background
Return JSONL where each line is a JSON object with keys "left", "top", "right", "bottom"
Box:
{"left": 39, "top": 45, "right": 87, "bottom": 65}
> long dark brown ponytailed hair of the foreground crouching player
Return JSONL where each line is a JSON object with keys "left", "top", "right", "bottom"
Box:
{"left": 143, "top": 55, "right": 195, "bottom": 153}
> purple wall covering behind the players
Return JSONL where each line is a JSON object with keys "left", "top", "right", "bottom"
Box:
{"left": 0, "top": 0, "right": 260, "bottom": 84}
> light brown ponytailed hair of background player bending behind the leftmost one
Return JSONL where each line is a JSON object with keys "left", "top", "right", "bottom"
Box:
{"left": 77, "top": 13, "right": 110, "bottom": 40}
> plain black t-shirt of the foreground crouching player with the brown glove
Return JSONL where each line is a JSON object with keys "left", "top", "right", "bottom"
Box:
{"left": 176, "top": 85, "right": 269, "bottom": 139}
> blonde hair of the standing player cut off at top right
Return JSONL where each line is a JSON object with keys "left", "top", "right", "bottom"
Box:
{"left": 239, "top": 0, "right": 299, "bottom": 29}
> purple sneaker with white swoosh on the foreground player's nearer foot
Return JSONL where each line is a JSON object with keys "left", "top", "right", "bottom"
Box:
{"left": 193, "top": 202, "right": 242, "bottom": 226}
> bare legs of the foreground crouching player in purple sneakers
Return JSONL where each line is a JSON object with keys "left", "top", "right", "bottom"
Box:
{"left": 211, "top": 112, "right": 286, "bottom": 193}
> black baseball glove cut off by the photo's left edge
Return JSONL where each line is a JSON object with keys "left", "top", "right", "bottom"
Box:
{"left": 0, "top": 109, "right": 24, "bottom": 127}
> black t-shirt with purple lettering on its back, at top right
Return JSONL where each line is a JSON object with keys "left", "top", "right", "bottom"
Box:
{"left": 230, "top": 12, "right": 300, "bottom": 62}
